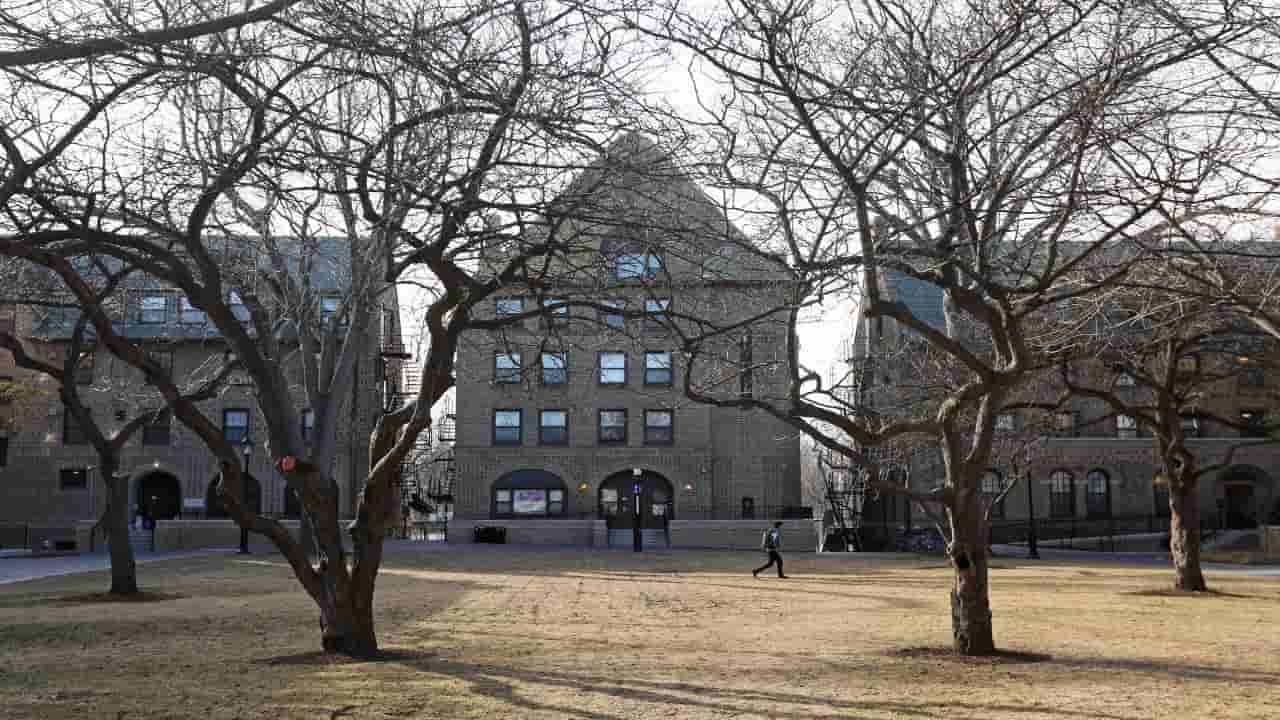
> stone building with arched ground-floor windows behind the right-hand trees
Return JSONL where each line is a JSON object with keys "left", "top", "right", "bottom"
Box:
{"left": 849, "top": 273, "right": 1280, "bottom": 547}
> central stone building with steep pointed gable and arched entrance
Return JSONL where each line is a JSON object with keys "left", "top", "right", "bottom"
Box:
{"left": 449, "top": 135, "right": 803, "bottom": 546}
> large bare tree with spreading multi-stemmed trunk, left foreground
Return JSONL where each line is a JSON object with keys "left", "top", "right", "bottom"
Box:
{"left": 0, "top": 1, "right": 655, "bottom": 656}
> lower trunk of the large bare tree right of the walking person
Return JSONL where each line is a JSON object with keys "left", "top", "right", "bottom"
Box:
{"left": 951, "top": 500, "right": 996, "bottom": 655}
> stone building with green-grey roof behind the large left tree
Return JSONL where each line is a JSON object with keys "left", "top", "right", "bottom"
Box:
{"left": 0, "top": 241, "right": 403, "bottom": 544}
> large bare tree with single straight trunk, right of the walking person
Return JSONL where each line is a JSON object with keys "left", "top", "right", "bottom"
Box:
{"left": 640, "top": 0, "right": 1264, "bottom": 655}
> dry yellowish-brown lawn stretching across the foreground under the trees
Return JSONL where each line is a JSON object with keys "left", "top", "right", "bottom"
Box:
{"left": 0, "top": 547, "right": 1280, "bottom": 720}
